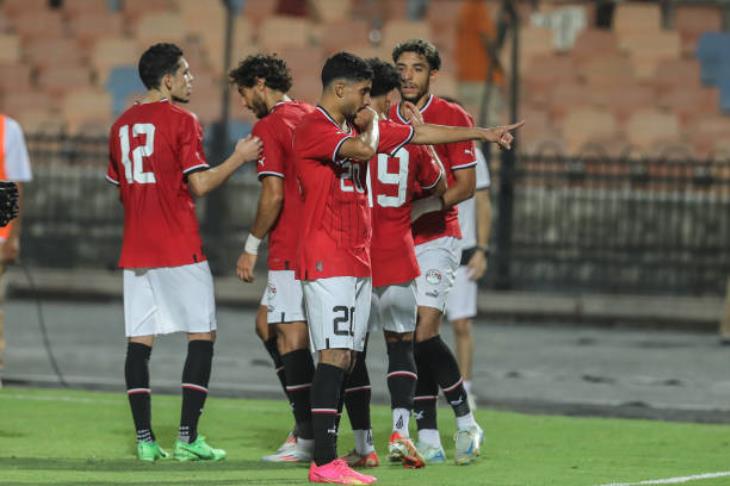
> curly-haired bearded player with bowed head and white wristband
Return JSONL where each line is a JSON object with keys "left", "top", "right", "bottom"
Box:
{"left": 229, "top": 54, "right": 314, "bottom": 463}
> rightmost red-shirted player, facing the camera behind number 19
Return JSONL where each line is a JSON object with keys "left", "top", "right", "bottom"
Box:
{"left": 391, "top": 39, "right": 521, "bottom": 464}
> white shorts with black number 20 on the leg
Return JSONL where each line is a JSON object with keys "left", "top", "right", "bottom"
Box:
{"left": 302, "top": 277, "right": 372, "bottom": 351}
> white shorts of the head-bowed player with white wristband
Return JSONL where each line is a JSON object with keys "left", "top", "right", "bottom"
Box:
{"left": 261, "top": 270, "right": 307, "bottom": 324}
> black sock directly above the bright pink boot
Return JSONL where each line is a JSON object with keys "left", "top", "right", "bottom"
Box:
{"left": 312, "top": 363, "right": 345, "bottom": 466}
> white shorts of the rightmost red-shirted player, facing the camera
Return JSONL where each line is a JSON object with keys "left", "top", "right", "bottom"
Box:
{"left": 416, "top": 236, "right": 461, "bottom": 312}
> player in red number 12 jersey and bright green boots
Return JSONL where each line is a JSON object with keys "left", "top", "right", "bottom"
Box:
{"left": 106, "top": 44, "right": 261, "bottom": 462}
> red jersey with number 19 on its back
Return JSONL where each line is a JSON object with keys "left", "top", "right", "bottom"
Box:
{"left": 369, "top": 139, "right": 441, "bottom": 287}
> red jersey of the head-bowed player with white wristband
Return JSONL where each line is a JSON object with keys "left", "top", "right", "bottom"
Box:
{"left": 252, "top": 101, "right": 314, "bottom": 270}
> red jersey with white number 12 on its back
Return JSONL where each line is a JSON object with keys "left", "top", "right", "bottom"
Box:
{"left": 106, "top": 100, "right": 208, "bottom": 268}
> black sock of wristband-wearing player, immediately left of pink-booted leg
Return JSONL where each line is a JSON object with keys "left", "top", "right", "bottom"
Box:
{"left": 281, "top": 349, "right": 314, "bottom": 439}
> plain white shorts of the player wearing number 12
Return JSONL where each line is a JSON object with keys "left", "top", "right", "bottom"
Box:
{"left": 124, "top": 261, "right": 216, "bottom": 337}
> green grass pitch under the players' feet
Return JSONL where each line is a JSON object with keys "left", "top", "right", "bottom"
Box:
{"left": 0, "top": 388, "right": 730, "bottom": 486}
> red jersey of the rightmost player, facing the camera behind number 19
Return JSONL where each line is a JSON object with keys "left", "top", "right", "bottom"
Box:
{"left": 390, "top": 95, "right": 477, "bottom": 245}
